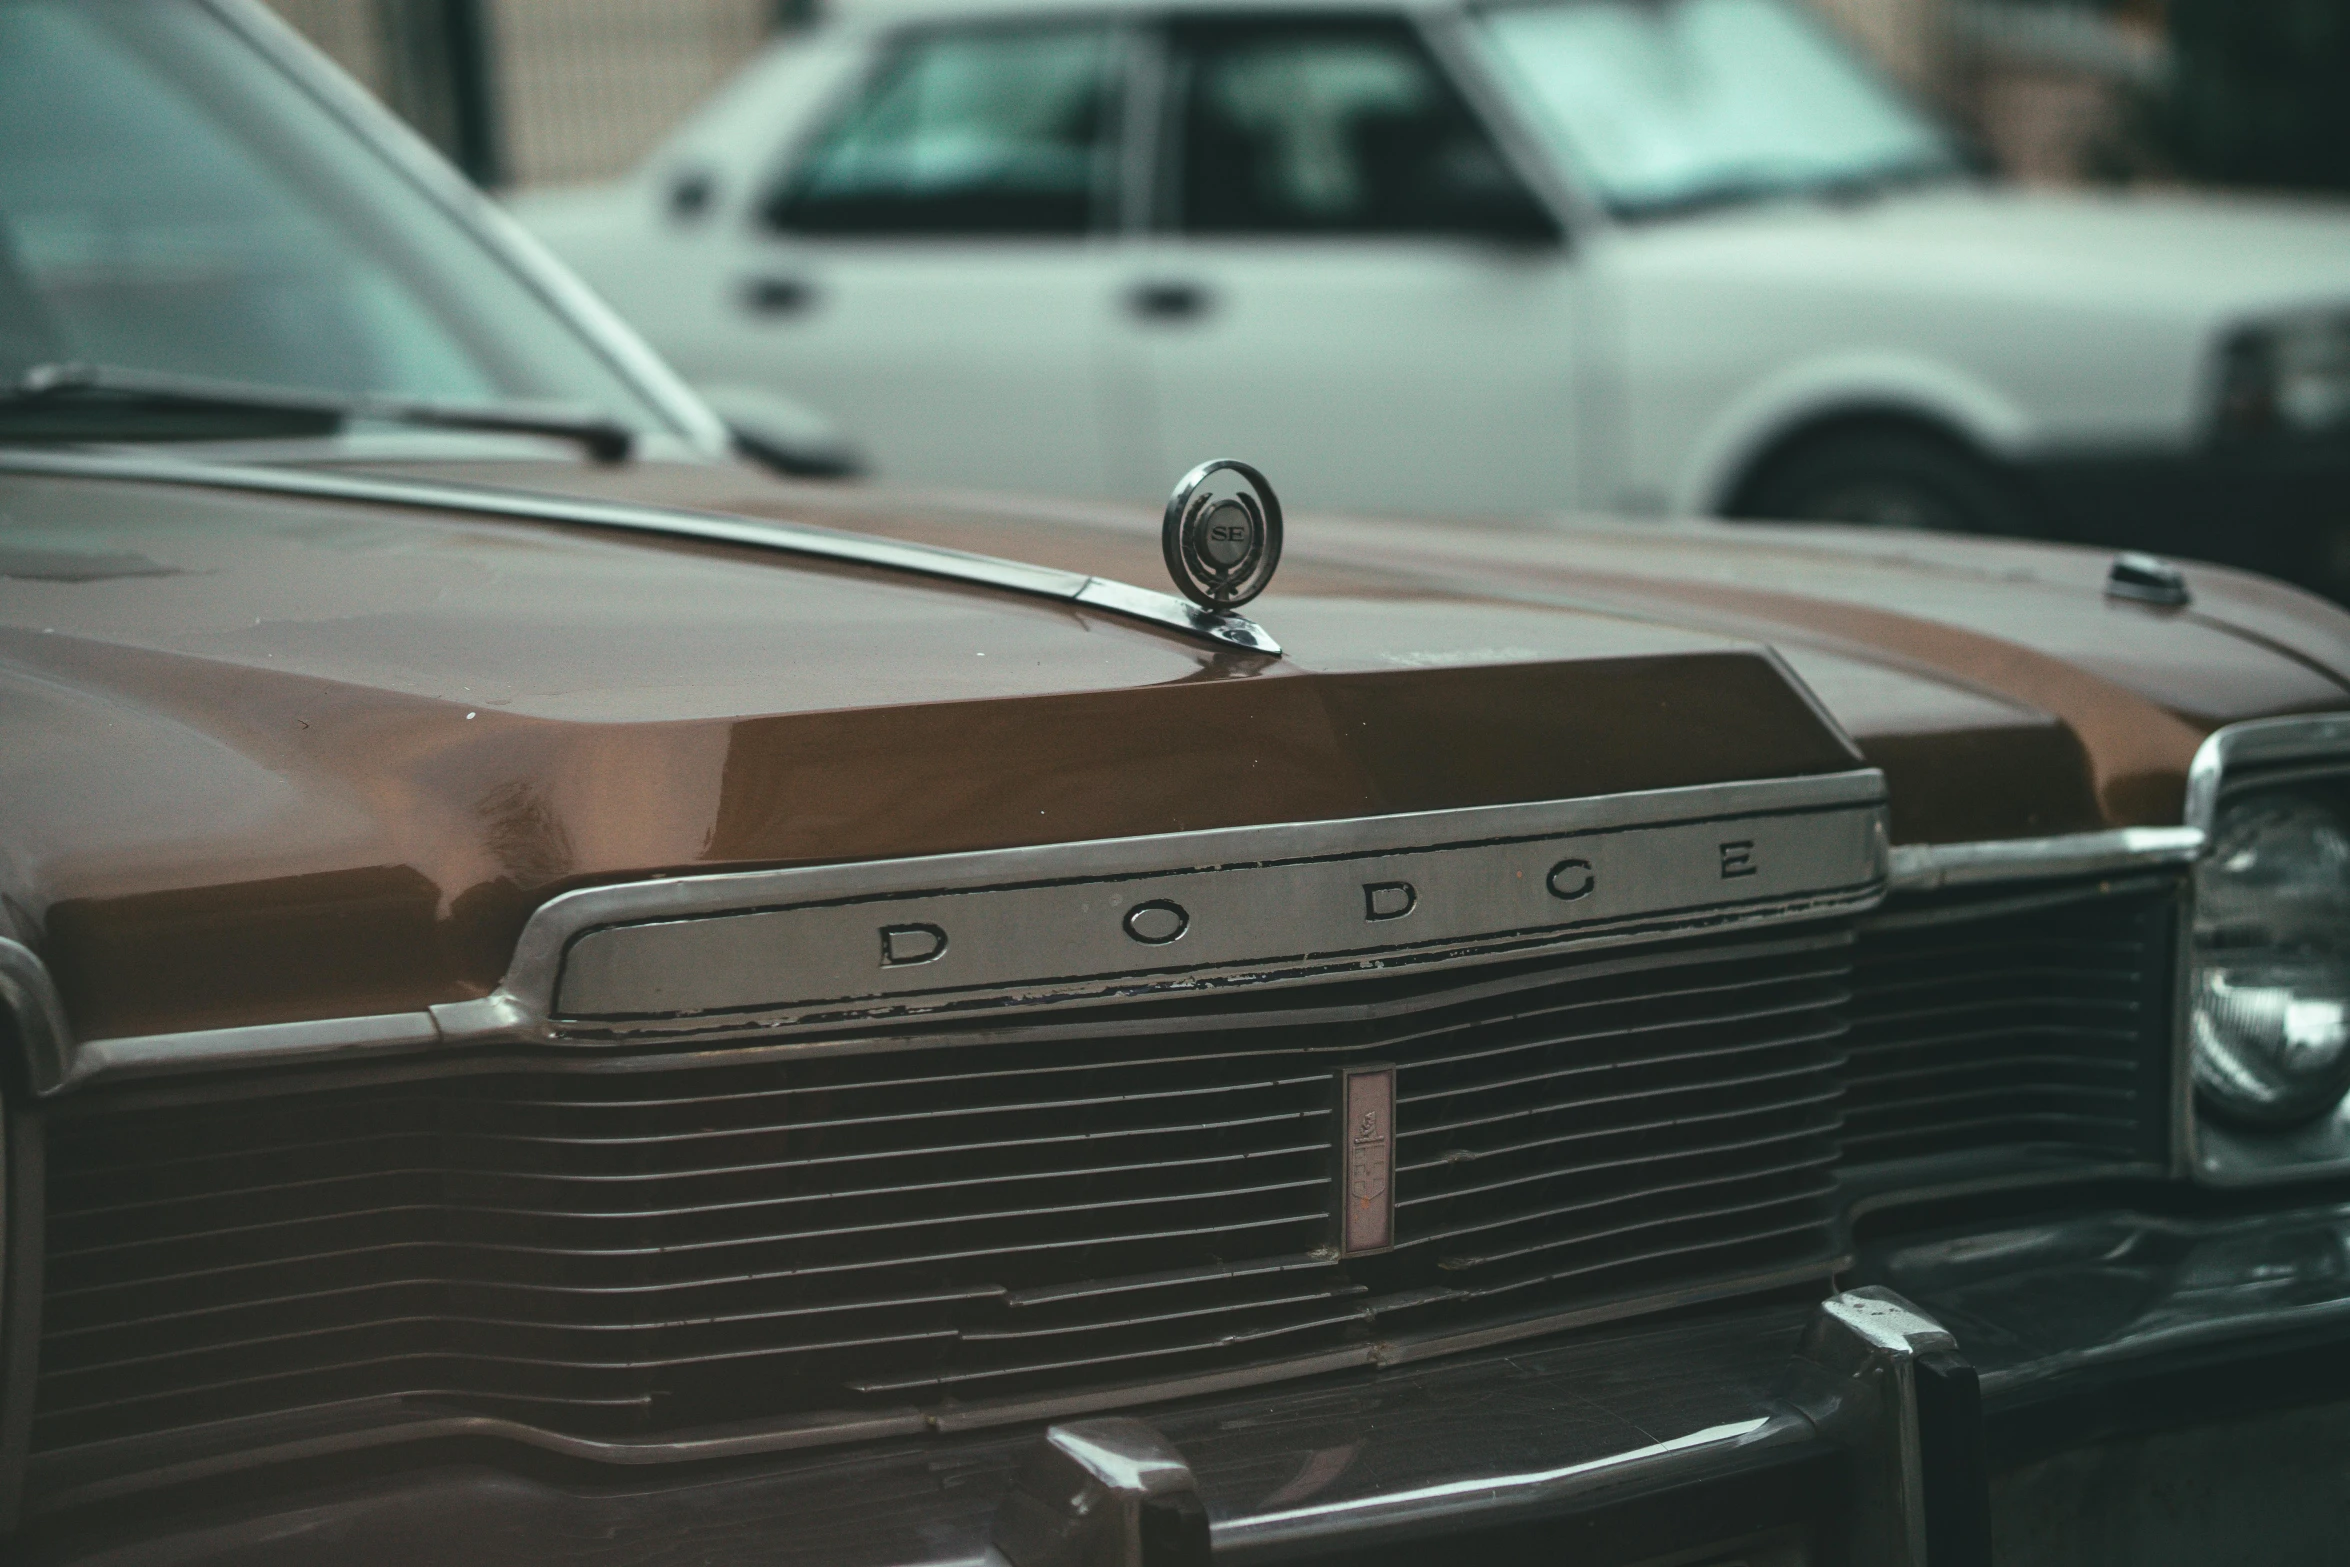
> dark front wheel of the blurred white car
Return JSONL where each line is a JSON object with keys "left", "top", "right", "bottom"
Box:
{"left": 1730, "top": 430, "right": 2037, "bottom": 533}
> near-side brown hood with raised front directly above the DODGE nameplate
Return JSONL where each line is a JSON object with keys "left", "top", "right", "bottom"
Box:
{"left": 0, "top": 477, "right": 1859, "bottom": 1036}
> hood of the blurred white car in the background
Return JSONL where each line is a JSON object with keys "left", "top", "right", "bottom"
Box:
{"left": 1612, "top": 186, "right": 2350, "bottom": 324}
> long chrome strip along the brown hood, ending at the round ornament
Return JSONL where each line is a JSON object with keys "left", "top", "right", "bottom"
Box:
{"left": 0, "top": 451, "right": 1281, "bottom": 658}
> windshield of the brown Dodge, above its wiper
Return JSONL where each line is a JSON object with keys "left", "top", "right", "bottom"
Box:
{"left": 0, "top": 0, "right": 670, "bottom": 428}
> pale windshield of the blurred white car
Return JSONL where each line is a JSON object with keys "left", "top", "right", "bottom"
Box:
{"left": 1481, "top": 0, "right": 1962, "bottom": 216}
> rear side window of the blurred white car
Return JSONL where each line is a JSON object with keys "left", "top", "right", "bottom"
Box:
{"left": 766, "top": 26, "right": 1121, "bottom": 235}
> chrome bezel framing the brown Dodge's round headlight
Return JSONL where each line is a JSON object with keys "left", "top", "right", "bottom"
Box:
{"left": 2174, "top": 714, "right": 2350, "bottom": 1186}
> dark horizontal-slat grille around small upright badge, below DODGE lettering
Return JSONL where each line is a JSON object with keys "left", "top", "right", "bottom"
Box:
{"left": 22, "top": 933, "right": 1849, "bottom": 1452}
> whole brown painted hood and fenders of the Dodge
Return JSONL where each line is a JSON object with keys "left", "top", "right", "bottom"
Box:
{"left": 0, "top": 451, "right": 2350, "bottom": 1038}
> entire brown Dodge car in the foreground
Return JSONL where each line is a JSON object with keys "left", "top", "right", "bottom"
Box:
{"left": 0, "top": 0, "right": 2350, "bottom": 1567}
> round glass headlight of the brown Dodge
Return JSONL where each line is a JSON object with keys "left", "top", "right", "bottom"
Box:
{"left": 2188, "top": 792, "right": 2350, "bottom": 1125}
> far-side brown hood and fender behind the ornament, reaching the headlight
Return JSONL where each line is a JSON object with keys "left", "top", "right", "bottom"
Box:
{"left": 495, "top": 453, "right": 2350, "bottom": 843}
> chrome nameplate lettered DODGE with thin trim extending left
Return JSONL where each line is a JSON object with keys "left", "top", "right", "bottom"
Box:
{"left": 13, "top": 768, "right": 1887, "bottom": 1095}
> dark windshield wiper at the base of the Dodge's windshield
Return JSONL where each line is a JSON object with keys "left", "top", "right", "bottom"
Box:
{"left": 0, "top": 364, "right": 637, "bottom": 463}
